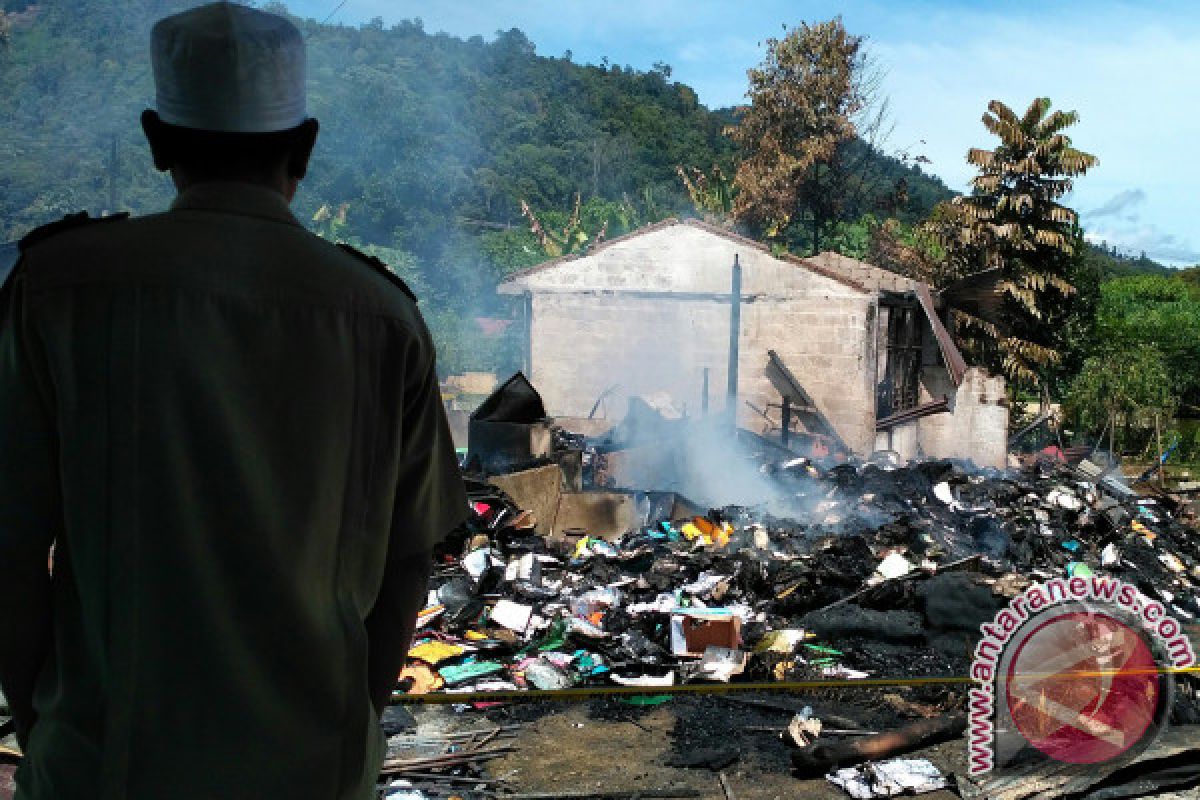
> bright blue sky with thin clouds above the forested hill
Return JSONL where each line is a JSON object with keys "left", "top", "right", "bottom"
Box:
{"left": 287, "top": 0, "right": 1200, "bottom": 264}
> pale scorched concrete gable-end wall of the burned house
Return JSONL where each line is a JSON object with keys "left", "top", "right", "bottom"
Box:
{"left": 506, "top": 224, "right": 876, "bottom": 451}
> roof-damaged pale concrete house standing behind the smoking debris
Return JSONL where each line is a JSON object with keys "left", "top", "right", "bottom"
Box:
{"left": 499, "top": 219, "right": 1008, "bottom": 467}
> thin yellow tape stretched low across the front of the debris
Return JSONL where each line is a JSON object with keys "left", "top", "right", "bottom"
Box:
{"left": 391, "top": 666, "right": 1200, "bottom": 705}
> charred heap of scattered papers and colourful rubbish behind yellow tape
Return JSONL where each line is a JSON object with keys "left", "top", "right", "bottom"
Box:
{"left": 406, "top": 450, "right": 1200, "bottom": 705}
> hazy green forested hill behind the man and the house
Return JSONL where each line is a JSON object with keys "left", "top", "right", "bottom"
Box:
{"left": 0, "top": 0, "right": 949, "bottom": 345}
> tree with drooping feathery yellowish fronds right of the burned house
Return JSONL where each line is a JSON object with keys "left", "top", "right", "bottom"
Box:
{"left": 930, "top": 97, "right": 1097, "bottom": 389}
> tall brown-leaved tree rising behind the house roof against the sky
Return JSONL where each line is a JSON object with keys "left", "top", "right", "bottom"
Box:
{"left": 730, "top": 18, "right": 866, "bottom": 253}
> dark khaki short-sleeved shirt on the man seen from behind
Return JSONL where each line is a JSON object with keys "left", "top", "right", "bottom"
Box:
{"left": 0, "top": 184, "right": 466, "bottom": 800}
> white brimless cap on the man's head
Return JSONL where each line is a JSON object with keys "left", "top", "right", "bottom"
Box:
{"left": 150, "top": 2, "right": 306, "bottom": 133}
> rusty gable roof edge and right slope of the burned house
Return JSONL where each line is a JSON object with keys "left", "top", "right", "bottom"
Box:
{"left": 502, "top": 217, "right": 917, "bottom": 293}
